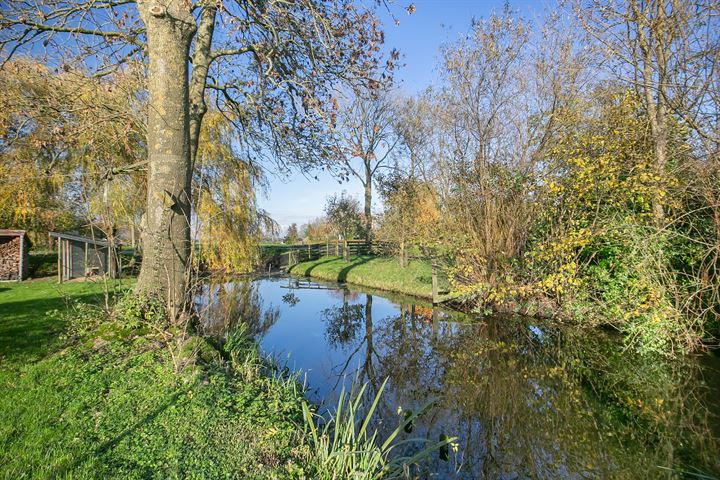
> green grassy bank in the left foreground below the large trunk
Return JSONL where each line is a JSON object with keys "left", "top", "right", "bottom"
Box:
{"left": 0, "top": 280, "right": 302, "bottom": 479}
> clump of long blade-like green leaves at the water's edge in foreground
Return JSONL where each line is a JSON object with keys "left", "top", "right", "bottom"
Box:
{"left": 303, "top": 379, "right": 454, "bottom": 480}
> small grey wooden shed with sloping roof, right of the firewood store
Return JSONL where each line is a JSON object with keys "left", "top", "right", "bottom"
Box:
{"left": 50, "top": 232, "right": 118, "bottom": 282}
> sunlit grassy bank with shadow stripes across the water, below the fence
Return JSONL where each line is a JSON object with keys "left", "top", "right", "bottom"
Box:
{"left": 290, "top": 255, "right": 448, "bottom": 299}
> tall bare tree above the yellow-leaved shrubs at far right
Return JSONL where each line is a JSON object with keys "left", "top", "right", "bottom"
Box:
{"left": 574, "top": 0, "right": 718, "bottom": 226}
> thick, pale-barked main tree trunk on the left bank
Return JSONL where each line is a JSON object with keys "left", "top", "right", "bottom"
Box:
{"left": 136, "top": 0, "right": 195, "bottom": 317}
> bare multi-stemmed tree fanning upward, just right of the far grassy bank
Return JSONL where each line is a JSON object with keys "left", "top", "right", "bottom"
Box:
{"left": 418, "top": 8, "right": 589, "bottom": 282}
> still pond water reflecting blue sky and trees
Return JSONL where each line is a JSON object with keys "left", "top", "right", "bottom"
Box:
{"left": 202, "top": 277, "right": 720, "bottom": 479}
